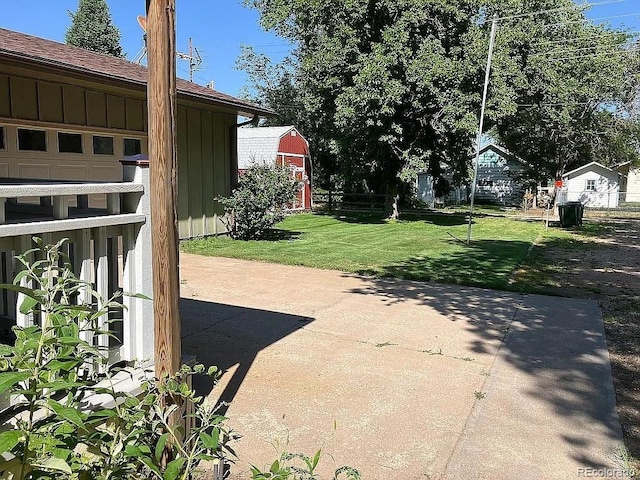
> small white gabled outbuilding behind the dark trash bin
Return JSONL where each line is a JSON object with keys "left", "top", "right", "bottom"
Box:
{"left": 558, "top": 162, "right": 620, "bottom": 208}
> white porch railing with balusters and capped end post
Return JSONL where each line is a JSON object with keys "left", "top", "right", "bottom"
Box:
{"left": 0, "top": 160, "right": 154, "bottom": 364}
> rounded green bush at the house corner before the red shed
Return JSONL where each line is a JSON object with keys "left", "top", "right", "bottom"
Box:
{"left": 216, "top": 164, "right": 301, "bottom": 240}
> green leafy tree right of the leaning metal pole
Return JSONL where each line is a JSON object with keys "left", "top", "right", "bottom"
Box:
{"left": 489, "top": 0, "right": 640, "bottom": 180}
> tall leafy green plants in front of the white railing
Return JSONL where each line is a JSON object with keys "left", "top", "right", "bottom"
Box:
{"left": 0, "top": 239, "right": 235, "bottom": 480}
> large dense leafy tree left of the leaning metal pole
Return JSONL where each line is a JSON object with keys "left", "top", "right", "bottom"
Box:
{"left": 249, "top": 0, "right": 481, "bottom": 204}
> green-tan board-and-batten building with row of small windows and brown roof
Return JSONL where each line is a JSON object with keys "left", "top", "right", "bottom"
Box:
{"left": 0, "top": 29, "right": 272, "bottom": 238}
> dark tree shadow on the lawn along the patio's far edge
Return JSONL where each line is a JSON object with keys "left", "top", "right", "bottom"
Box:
{"left": 357, "top": 240, "right": 531, "bottom": 290}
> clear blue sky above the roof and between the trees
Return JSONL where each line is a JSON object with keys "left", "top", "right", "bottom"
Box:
{"left": 0, "top": 0, "right": 640, "bottom": 95}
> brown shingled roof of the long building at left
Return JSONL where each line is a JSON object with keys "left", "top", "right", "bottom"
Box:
{"left": 0, "top": 28, "right": 274, "bottom": 116}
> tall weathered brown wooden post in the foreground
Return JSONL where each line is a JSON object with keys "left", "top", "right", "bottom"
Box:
{"left": 146, "top": 0, "right": 180, "bottom": 378}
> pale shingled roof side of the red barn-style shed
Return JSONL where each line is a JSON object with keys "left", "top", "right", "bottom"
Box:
{"left": 238, "top": 126, "right": 295, "bottom": 169}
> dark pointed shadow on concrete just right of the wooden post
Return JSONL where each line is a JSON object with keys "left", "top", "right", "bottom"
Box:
{"left": 180, "top": 298, "right": 314, "bottom": 415}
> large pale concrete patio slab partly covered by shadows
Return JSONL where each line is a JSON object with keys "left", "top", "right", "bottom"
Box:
{"left": 180, "top": 254, "right": 624, "bottom": 480}
